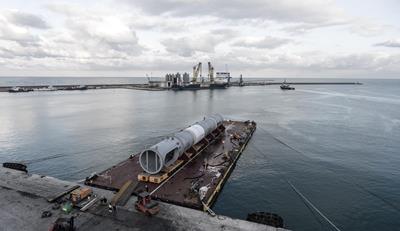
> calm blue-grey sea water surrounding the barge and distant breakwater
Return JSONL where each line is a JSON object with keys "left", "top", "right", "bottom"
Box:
{"left": 0, "top": 78, "right": 400, "bottom": 230}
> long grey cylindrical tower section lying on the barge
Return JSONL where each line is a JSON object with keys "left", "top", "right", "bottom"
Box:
{"left": 139, "top": 114, "right": 223, "bottom": 174}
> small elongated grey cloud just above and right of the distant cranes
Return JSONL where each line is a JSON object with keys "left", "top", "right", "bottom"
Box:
{"left": 232, "top": 36, "right": 291, "bottom": 49}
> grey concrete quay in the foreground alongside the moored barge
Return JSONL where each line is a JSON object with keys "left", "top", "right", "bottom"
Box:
{"left": 0, "top": 167, "right": 286, "bottom": 231}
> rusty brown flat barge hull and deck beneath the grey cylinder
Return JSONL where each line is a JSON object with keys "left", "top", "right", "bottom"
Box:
{"left": 85, "top": 121, "right": 256, "bottom": 210}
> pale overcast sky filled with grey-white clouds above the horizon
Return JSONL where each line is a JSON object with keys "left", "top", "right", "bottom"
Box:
{"left": 0, "top": 0, "right": 400, "bottom": 78}
